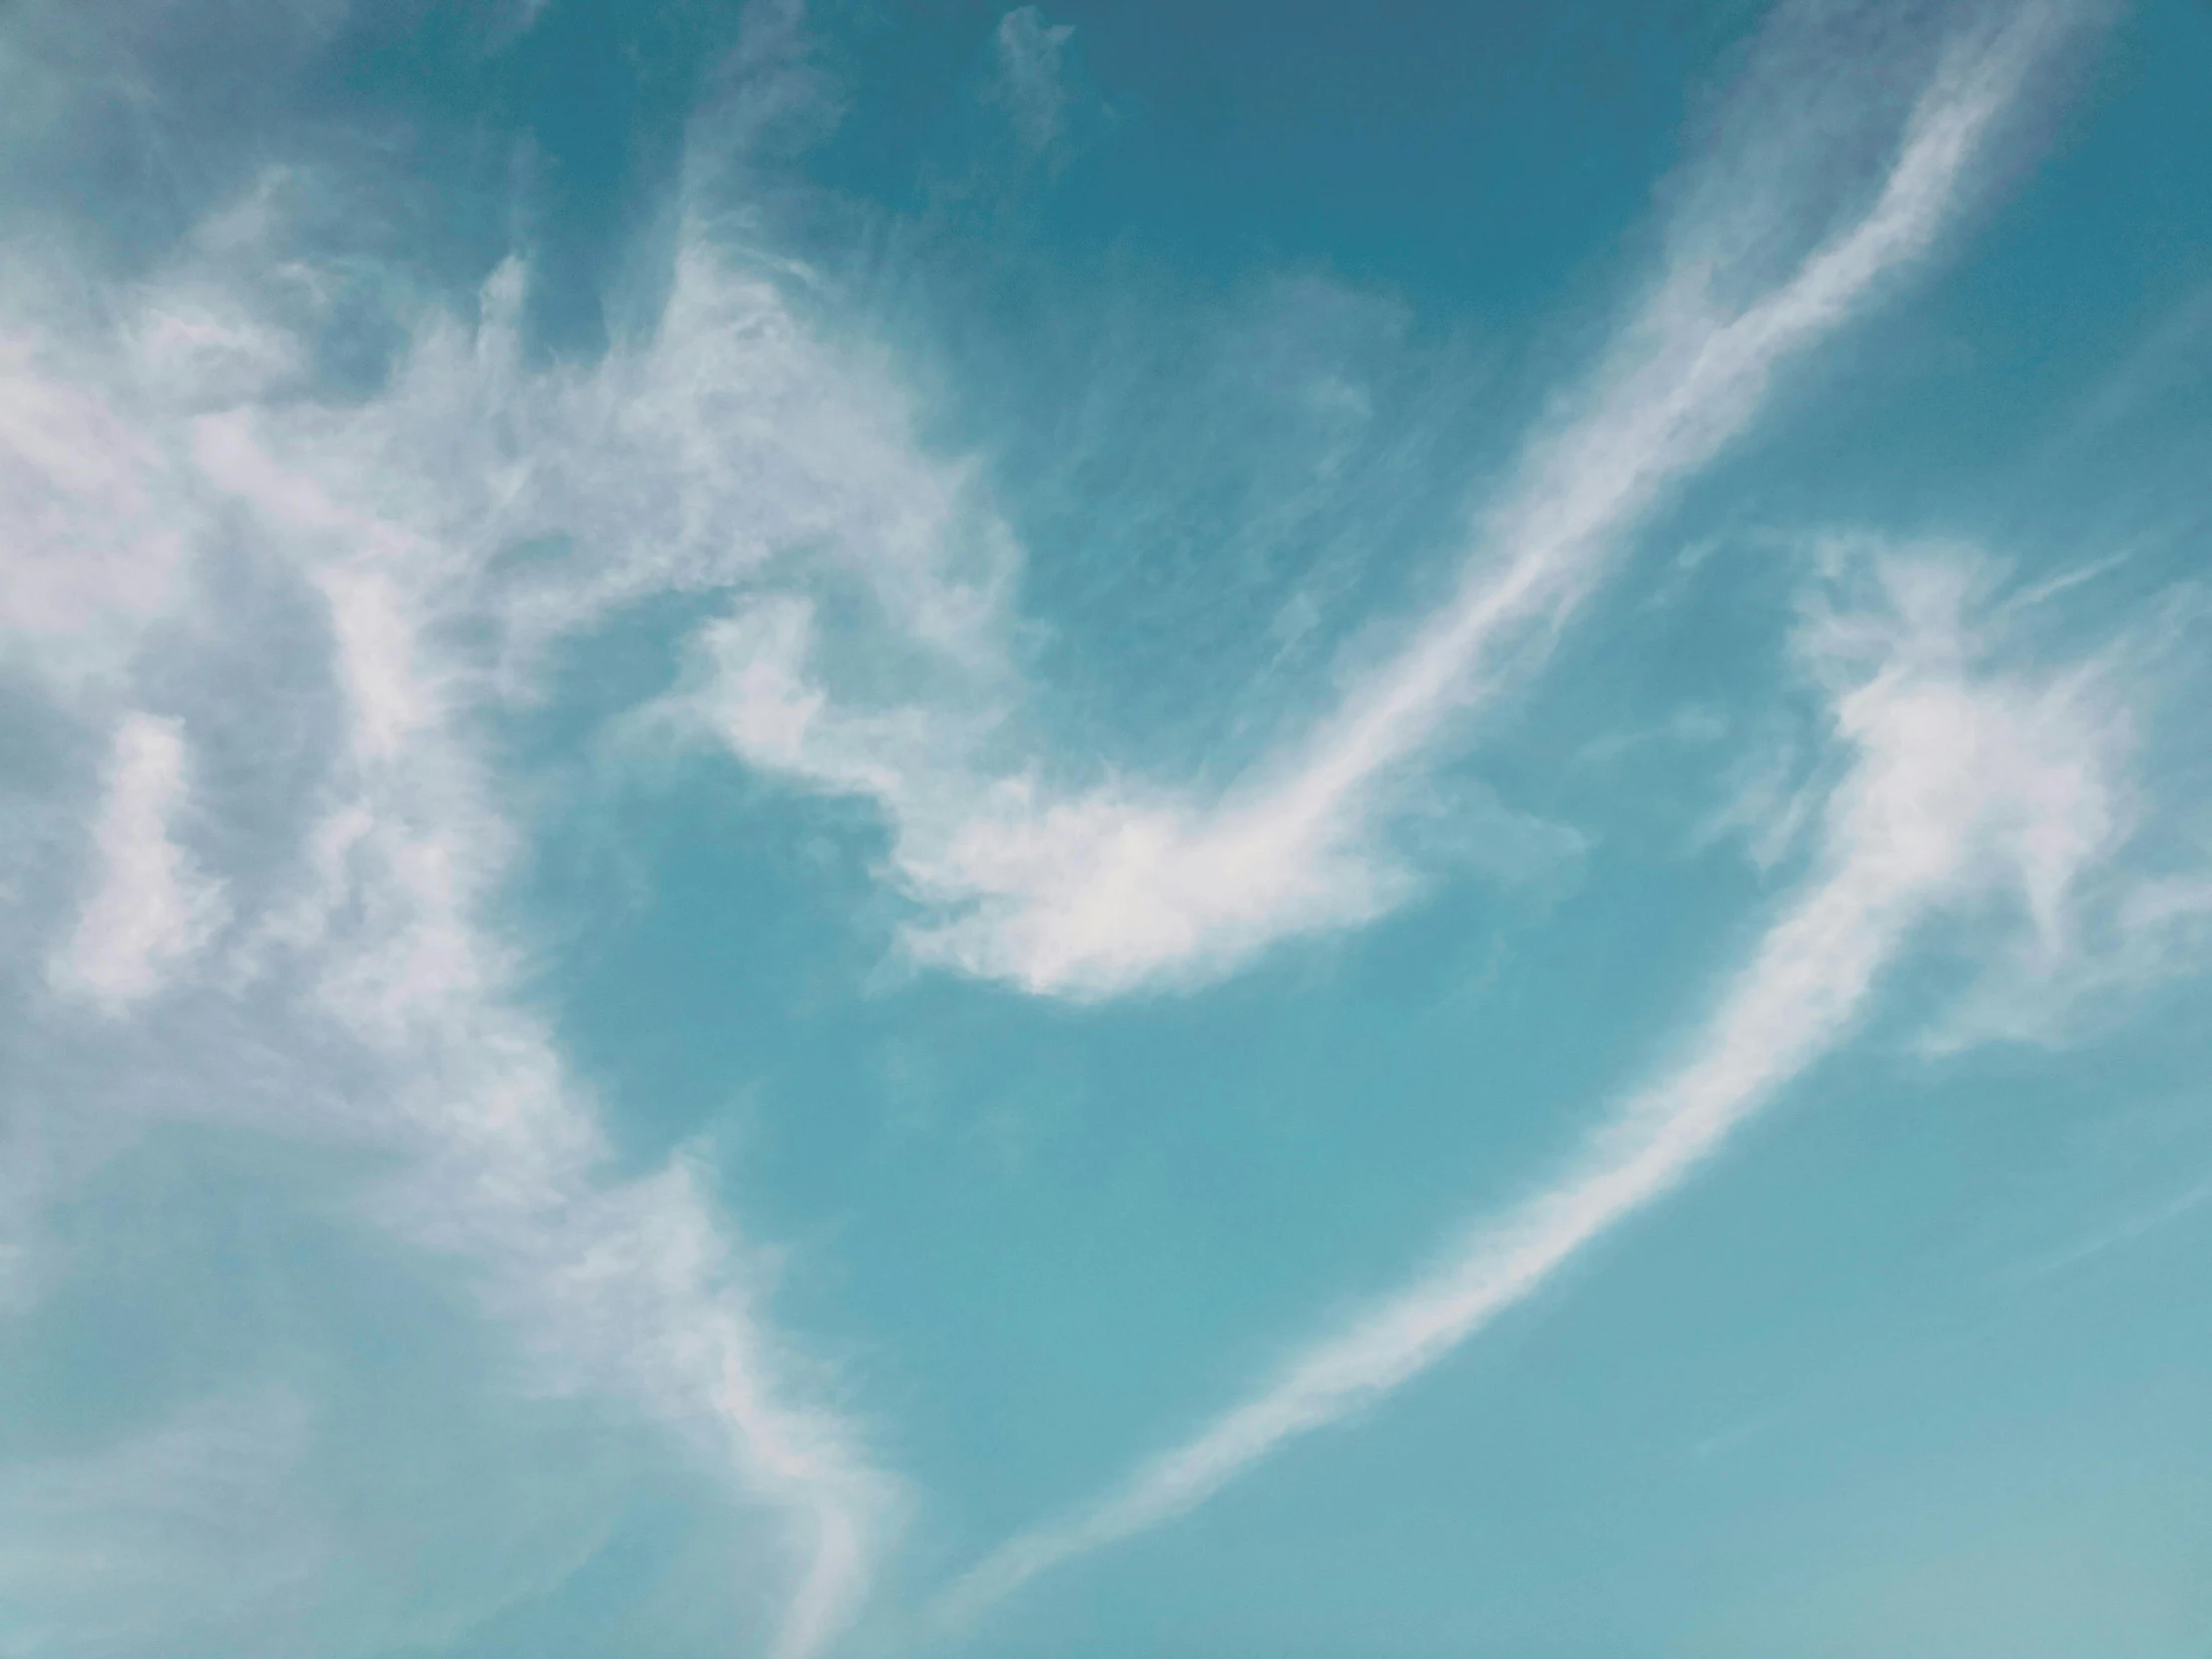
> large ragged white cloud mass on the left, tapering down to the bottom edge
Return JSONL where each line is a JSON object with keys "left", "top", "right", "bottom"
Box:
{"left": 0, "top": 177, "right": 915, "bottom": 1659}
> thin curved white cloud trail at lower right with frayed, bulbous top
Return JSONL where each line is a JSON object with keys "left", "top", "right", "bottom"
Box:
{"left": 935, "top": 548, "right": 2126, "bottom": 1628}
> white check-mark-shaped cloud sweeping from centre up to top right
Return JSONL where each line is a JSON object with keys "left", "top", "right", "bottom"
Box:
{"left": 675, "top": 7, "right": 2066, "bottom": 997}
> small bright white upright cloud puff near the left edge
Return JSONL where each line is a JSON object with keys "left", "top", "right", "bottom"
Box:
{"left": 47, "top": 715, "right": 228, "bottom": 1013}
